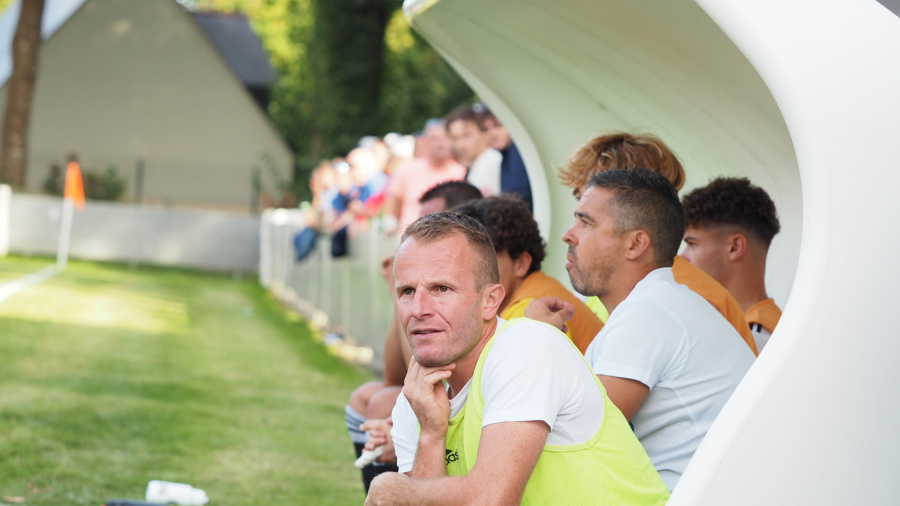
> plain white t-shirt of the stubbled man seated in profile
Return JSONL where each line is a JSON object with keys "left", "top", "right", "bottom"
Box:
{"left": 585, "top": 268, "right": 755, "bottom": 490}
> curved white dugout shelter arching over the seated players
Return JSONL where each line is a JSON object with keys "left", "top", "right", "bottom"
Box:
{"left": 404, "top": 0, "right": 900, "bottom": 505}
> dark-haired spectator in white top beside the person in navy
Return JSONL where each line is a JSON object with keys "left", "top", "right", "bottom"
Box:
{"left": 445, "top": 105, "right": 503, "bottom": 196}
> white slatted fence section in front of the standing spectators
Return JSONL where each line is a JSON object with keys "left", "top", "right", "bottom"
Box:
{"left": 259, "top": 209, "right": 396, "bottom": 372}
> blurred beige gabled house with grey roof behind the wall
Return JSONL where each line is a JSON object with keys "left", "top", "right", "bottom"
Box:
{"left": 0, "top": 0, "right": 294, "bottom": 211}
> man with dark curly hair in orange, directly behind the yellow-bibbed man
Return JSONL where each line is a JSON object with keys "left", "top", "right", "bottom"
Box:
{"left": 451, "top": 196, "right": 603, "bottom": 353}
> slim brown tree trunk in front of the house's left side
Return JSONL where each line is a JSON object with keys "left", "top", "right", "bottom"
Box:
{"left": 0, "top": 0, "right": 44, "bottom": 189}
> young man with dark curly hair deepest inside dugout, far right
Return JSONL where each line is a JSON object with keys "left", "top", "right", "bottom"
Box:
{"left": 682, "top": 178, "right": 781, "bottom": 351}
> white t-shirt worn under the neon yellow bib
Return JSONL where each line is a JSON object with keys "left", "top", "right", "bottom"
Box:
{"left": 391, "top": 318, "right": 603, "bottom": 473}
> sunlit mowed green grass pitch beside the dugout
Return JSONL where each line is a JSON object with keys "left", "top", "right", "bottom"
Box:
{"left": 0, "top": 258, "right": 369, "bottom": 506}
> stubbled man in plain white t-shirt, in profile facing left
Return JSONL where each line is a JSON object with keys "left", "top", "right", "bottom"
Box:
{"left": 528, "top": 169, "right": 754, "bottom": 490}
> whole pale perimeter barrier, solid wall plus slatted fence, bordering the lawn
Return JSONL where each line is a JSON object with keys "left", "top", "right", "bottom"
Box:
{"left": 0, "top": 190, "right": 395, "bottom": 372}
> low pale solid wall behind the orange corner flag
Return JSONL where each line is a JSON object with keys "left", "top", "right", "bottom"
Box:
{"left": 9, "top": 193, "right": 259, "bottom": 272}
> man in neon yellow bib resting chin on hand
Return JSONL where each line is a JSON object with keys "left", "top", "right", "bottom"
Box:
{"left": 366, "top": 213, "right": 668, "bottom": 505}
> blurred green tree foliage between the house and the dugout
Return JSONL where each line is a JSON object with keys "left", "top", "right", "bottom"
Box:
{"left": 180, "top": 0, "right": 474, "bottom": 200}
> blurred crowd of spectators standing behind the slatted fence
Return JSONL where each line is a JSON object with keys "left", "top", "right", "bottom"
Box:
{"left": 295, "top": 103, "right": 532, "bottom": 260}
